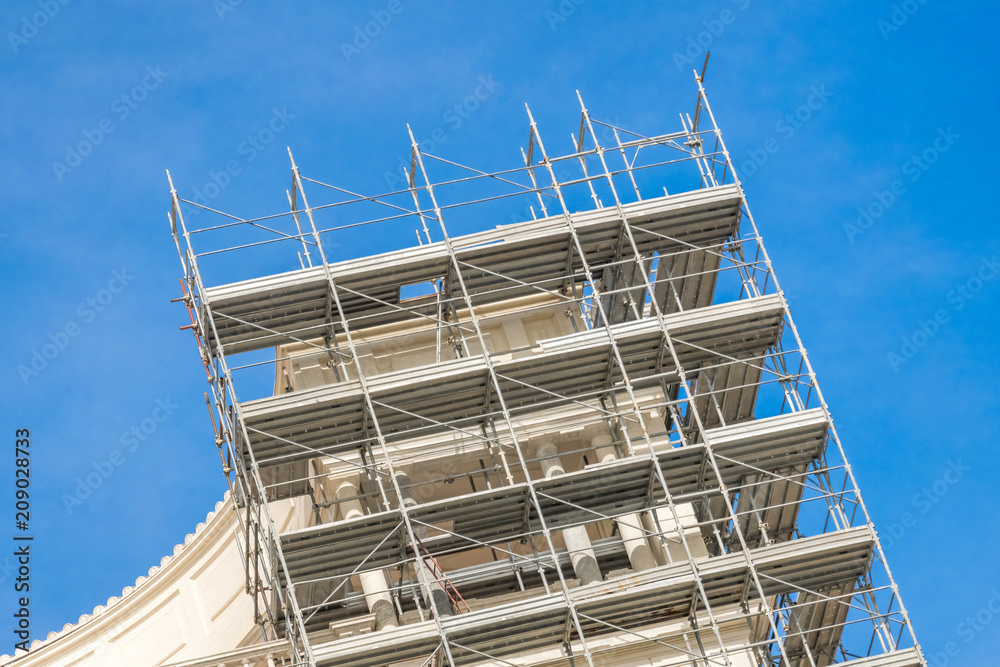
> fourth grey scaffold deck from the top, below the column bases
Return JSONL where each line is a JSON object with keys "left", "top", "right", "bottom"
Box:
{"left": 314, "top": 527, "right": 868, "bottom": 667}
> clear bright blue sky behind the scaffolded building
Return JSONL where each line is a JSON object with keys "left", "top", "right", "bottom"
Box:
{"left": 0, "top": 0, "right": 1000, "bottom": 665}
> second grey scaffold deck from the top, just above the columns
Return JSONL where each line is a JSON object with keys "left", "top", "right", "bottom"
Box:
{"left": 242, "top": 295, "right": 782, "bottom": 467}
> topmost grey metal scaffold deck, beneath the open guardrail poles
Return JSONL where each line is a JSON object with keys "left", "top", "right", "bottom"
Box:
{"left": 203, "top": 185, "right": 740, "bottom": 354}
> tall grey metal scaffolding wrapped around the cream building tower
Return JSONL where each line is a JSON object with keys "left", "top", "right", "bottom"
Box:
{"left": 168, "top": 70, "right": 926, "bottom": 667}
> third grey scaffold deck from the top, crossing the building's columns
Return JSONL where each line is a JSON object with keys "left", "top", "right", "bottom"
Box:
{"left": 281, "top": 409, "right": 828, "bottom": 580}
